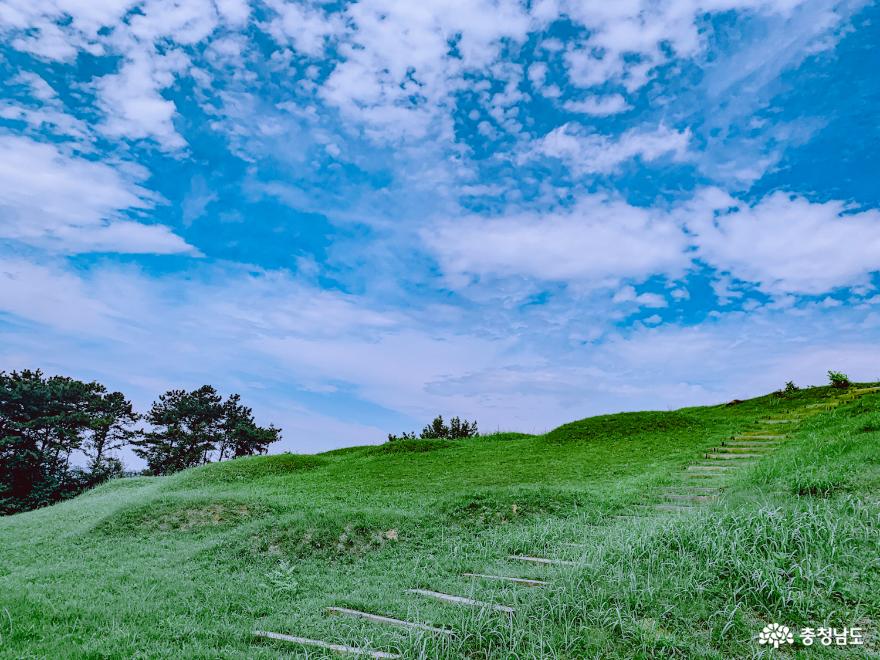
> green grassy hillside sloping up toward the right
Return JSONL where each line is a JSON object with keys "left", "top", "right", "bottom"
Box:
{"left": 0, "top": 388, "right": 880, "bottom": 658}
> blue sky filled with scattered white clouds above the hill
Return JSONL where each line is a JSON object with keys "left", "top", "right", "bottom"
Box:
{"left": 0, "top": 0, "right": 880, "bottom": 451}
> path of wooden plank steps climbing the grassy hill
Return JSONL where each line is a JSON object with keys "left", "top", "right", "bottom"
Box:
{"left": 253, "top": 387, "right": 880, "bottom": 658}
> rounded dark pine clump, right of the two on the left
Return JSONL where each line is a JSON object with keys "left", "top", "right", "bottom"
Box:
{"left": 131, "top": 385, "right": 281, "bottom": 475}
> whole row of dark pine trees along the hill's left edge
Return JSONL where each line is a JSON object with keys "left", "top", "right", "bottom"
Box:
{"left": 0, "top": 369, "right": 281, "bottom": 514}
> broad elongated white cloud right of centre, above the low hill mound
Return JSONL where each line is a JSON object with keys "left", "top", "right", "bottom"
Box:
{"left": 423, "top": 196, "right": 689, "bottom": 286}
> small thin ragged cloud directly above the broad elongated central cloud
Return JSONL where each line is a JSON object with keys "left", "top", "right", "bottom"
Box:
{"left": 523, "top": 123, "right": 691, "bottom": 174}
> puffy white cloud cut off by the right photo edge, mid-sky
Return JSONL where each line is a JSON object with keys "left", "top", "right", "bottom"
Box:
{"left": 688, "top": 192, "right": 880, "bottom": 294}
